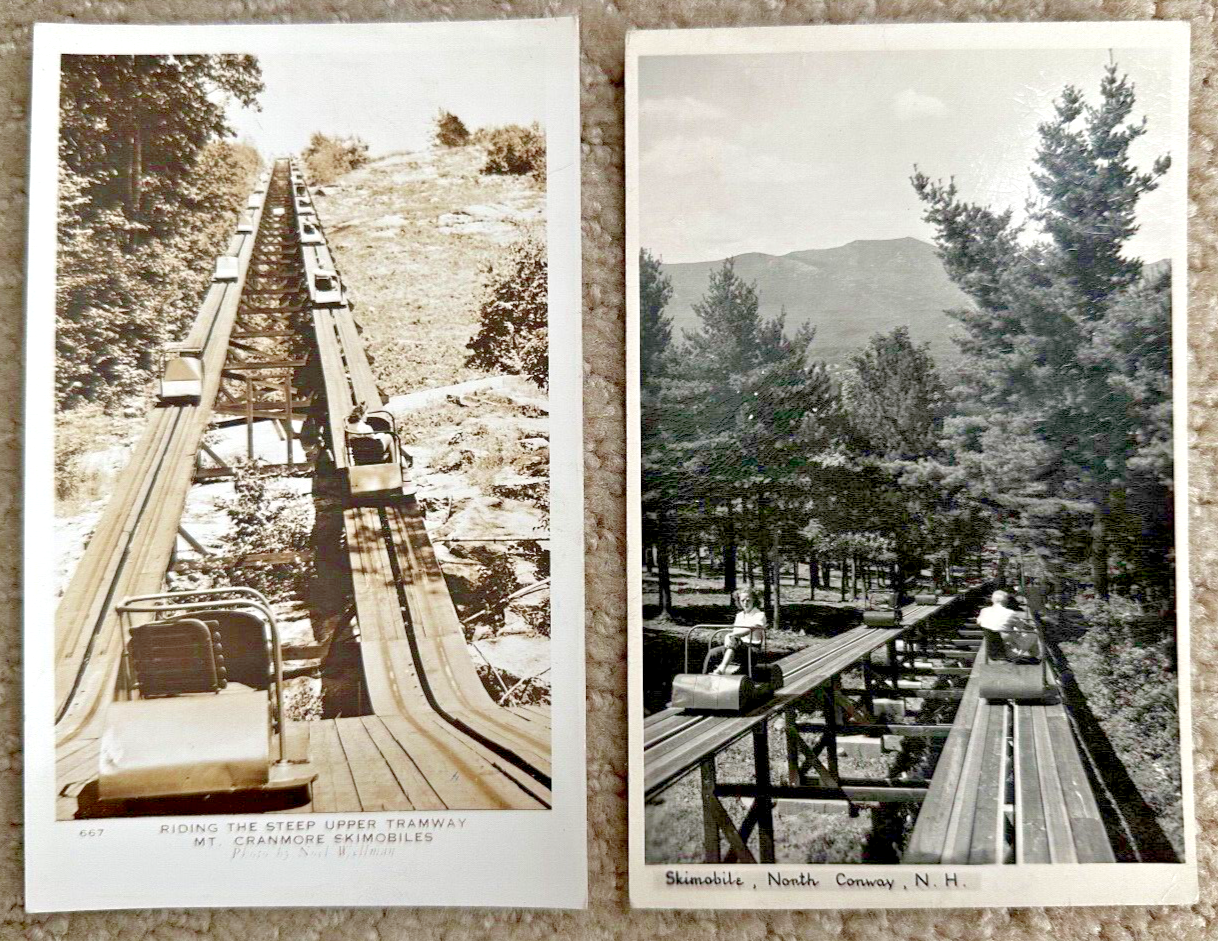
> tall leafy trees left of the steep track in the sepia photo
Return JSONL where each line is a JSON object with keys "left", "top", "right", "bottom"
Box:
{"left": 56, "top": 55, "right": 262, "bottom": 407}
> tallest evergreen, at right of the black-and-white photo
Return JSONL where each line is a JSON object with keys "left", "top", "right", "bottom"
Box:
{"left": 912, "top": 66, "right": 1170, "bottom": 595}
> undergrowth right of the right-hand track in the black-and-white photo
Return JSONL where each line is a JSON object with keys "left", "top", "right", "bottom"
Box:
{"left": 1069, "top": 596, "right": 1184, "bottom": 858}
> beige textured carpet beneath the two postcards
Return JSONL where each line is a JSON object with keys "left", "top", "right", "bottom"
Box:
{"left": 0, "top": 0, "right": 1218, "bottom": 941}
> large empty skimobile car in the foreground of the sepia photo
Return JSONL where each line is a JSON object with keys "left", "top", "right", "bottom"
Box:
{"left": 97, "top": 588, "right": 317, "bottom": 801}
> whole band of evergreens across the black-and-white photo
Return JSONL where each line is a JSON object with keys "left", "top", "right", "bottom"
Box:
{"left": 639, "top": 67, "right": 1174, "bottom": 615}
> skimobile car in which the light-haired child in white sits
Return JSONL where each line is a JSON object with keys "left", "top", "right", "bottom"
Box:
{"left": 669, "top": 624, "right": 783, "bottom": 712}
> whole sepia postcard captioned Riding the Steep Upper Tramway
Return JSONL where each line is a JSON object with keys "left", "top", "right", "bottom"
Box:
{"left": 24, "top": 18, "right": 587, "bottom": 912}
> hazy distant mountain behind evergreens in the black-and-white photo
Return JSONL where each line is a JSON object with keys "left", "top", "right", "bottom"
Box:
{"left": 664, "top": 239, "right": 971, "bottom": 365}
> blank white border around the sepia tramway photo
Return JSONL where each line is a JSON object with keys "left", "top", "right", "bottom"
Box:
{"left": 23, "top": 17, "right": 587, "bottom": 912}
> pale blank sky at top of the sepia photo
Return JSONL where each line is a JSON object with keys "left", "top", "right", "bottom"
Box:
{"left": 229, "top": 43, "right": 546, "bottom": 156}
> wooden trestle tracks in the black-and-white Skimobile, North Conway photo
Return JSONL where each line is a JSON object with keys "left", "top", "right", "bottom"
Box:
{"left": 643, "top": 595, "right": 1114, "bottom": 864}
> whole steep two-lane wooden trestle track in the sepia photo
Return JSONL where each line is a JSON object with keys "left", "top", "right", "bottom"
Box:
{"left": 55, "top": 161, "right": 551, "bottom": 819}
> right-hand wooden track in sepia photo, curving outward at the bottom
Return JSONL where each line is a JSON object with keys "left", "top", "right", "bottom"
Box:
{"left": 303, "top": 180, "right": 551, "bottom": 808}
